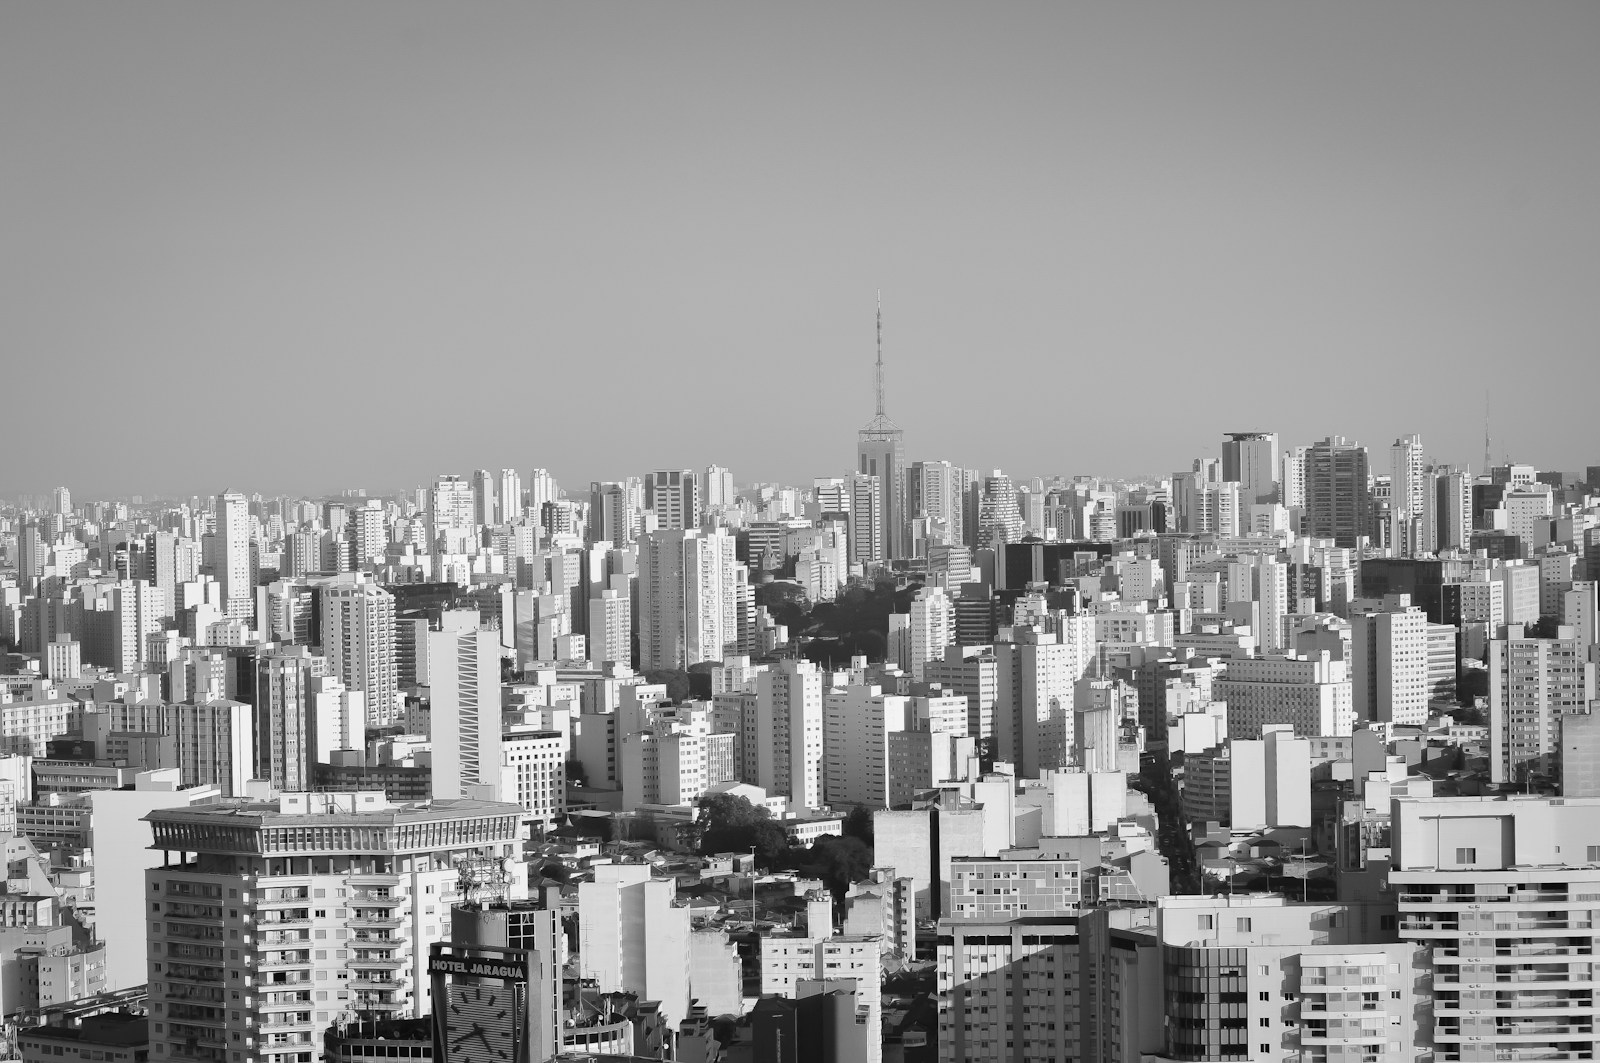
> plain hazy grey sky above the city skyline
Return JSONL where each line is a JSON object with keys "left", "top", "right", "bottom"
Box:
{"left": 0, "top": 0, "right": 1600, "bottom": 498}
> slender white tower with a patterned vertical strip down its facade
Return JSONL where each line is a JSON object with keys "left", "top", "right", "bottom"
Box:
{"left": 427, "top": 608, "right": 504, "bottom": 797}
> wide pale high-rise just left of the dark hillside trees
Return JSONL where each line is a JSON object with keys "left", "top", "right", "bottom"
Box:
{"left": 638, "top": 528, "right": 746, "bottom": 669}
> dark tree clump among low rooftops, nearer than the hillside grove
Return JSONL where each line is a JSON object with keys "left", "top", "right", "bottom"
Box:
{"left": 691, "top": 794, "right": 872, "bottom": 898}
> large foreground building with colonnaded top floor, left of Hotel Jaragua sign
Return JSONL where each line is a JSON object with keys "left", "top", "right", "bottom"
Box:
{"left": 144, "top": 792, "right": 526, "bottom": 1063}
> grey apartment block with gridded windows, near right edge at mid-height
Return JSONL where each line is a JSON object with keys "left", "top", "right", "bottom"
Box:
{"left": 1488, "top": 624, "right": 1595, "bottom": 786}
